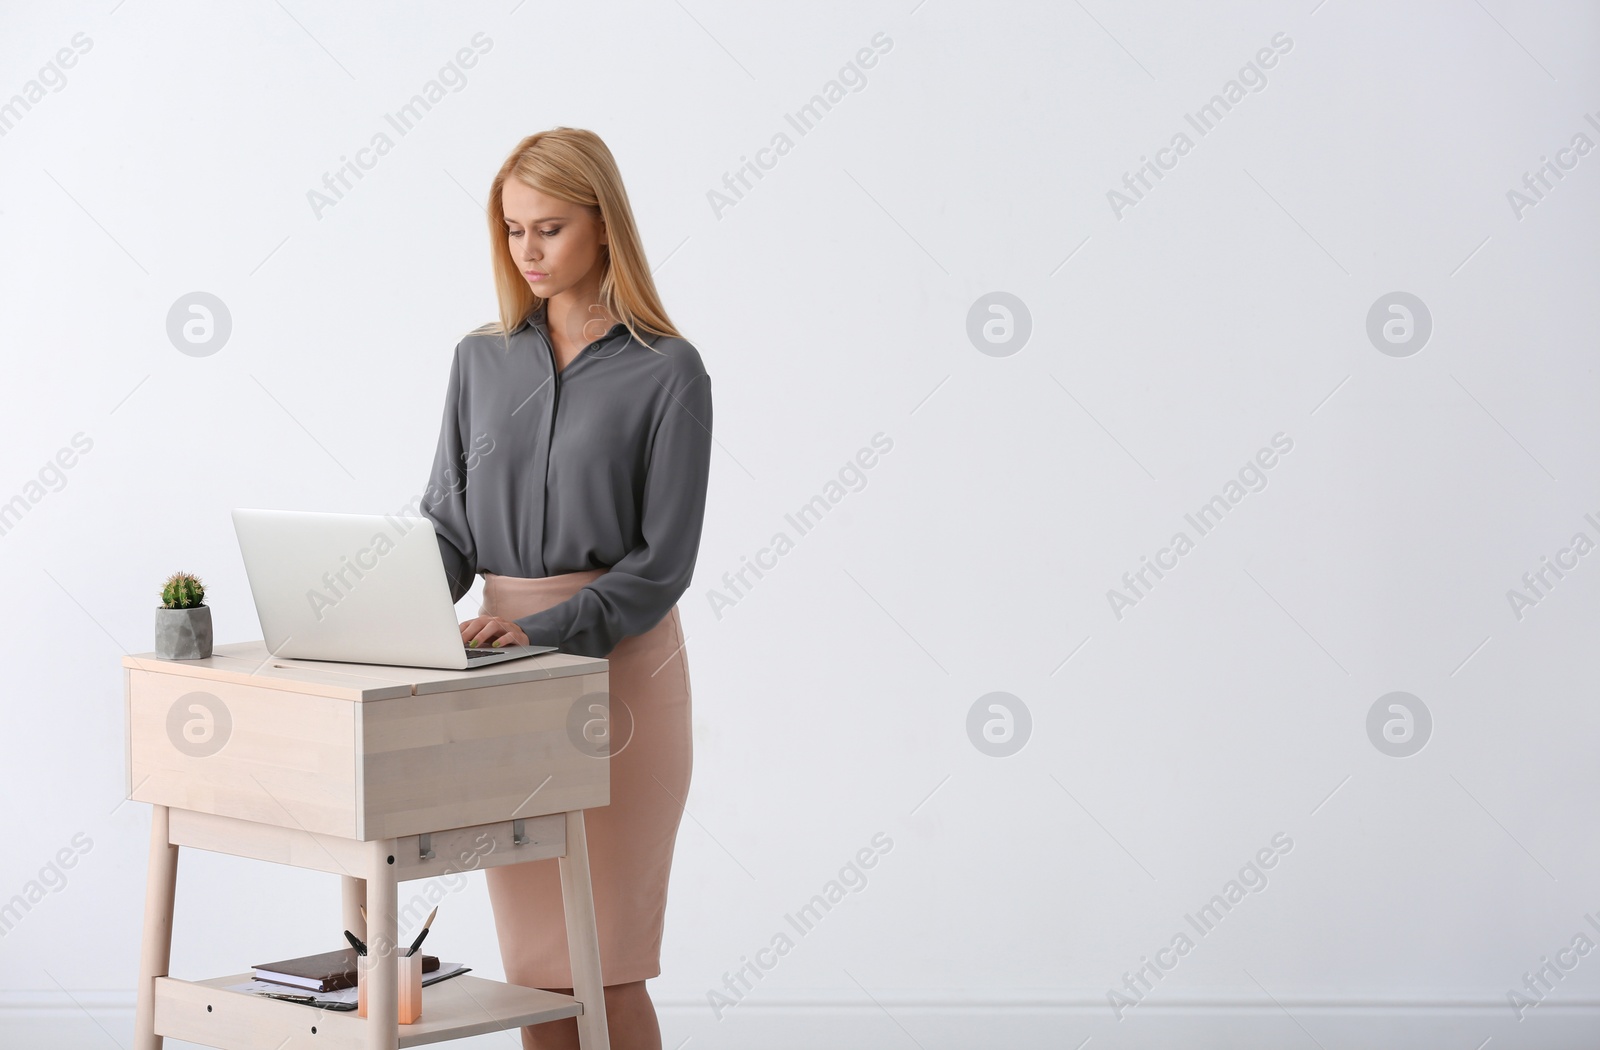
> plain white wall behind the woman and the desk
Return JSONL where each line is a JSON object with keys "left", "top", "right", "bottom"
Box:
{"left": 0, "top": 0, "right": 1600, "bottom": 1048}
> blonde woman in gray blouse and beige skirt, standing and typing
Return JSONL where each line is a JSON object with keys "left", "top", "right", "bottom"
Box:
{"left": 424, "top": 128, "right": 710, "bottom": 1050}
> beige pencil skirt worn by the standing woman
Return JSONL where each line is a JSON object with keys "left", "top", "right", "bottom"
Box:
{"left": 478, "top": 568, "right": 693, "bottom": 989}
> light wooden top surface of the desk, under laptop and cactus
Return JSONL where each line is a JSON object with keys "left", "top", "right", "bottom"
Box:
{"left": 122, "top": 639, "right": 611, "bottom": 701}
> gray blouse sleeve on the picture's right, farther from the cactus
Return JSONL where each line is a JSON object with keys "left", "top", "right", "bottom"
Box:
{"left": 512, "top": 371, "right": 712, "bottom": 656}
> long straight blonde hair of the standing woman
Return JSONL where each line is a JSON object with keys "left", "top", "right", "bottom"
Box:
{"left": 470, "top": 128, "right": 683, "bottom": 352}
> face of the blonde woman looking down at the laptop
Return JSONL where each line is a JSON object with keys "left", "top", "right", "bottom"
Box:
{"left": 501, "top": 179, "right": 605, "bottom": 299}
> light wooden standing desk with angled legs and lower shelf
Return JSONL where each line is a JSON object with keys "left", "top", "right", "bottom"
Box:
{"left": 122, "top": 642, "right": 611, "bottom": 1050}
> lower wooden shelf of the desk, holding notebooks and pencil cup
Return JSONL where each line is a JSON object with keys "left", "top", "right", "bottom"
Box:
{"left": 155, "top": 973, "right": 584, "bottom": 1050}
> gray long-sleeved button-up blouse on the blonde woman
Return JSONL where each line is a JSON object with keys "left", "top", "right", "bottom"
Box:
{"left": 422, "top": 304, "right": 710, "bottom": 656}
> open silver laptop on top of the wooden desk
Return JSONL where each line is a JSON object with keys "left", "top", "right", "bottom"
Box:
{"left": 234, "top": 509, "right": 555, "bottom": 671}
